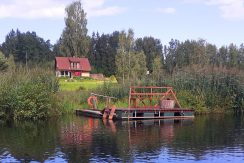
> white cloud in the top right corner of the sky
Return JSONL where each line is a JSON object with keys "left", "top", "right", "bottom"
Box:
{"left": 183, "top": 0, "right": 244, "bottom": 20}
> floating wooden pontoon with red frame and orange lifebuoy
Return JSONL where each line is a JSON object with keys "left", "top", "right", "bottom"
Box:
{"left": 76, "top": 86, "right": 194, "bottom": 120}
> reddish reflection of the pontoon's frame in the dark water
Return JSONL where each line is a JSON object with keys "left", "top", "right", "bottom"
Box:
{"left": 89, "top": 120, "right": 191, "bottom": 162}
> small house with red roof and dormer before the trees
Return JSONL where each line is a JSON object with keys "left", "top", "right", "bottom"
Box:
{"left": 55, "top": 57, "right": 91, "bottom": 78}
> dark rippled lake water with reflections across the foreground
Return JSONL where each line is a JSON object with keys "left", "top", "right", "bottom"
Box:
{"left": 0, "top": 115, "right": 244, "bottom": 163}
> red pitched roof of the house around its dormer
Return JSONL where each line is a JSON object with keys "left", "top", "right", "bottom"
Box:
{"left": 55, "top": 57, "right": 91, "bottom": 71}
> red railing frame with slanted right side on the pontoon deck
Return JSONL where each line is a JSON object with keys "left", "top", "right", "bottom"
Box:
{"left": 128, "top": 86, "right": 181, "bottom": 109}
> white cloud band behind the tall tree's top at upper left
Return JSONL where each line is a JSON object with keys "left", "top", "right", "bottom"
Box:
{"left": 0, "top": 0, "right": 124, "bottom": 19}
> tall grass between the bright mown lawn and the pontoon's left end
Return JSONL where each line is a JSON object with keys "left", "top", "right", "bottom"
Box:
{"left": 58, "top": 81, "right": 129, "bottom": 113}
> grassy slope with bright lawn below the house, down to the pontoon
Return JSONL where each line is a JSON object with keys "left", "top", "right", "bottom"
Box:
{"left": 57, "top": 78, "right": 122, "bottom": 113}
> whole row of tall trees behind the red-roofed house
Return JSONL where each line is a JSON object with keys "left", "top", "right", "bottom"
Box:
{"left": 0, "top": 1, "right": 244, "bottom": 78}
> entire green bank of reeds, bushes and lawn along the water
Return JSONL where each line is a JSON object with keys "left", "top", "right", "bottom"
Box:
{"left": 0, "top": 68, "right": 244, "bottom": 120}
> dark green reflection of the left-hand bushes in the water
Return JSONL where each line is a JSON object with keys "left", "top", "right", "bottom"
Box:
{"left": 0, "top": 121, "right": 58, "bottom": 162}
